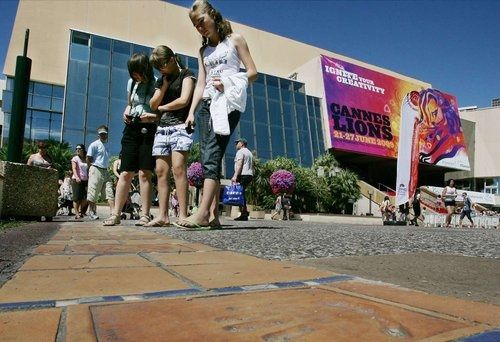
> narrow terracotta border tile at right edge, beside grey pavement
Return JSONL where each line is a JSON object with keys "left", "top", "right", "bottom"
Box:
{"left": 325, "top": 281, "right": 500, "bottom": 326}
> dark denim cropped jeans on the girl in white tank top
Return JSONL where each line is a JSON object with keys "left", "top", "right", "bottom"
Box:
{"left": 198, "top": 100, "right": 241, "bottom": 180}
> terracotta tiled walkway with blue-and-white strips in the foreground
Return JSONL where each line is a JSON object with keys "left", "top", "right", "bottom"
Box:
{"left": 0, "top": 222, "right": 500, "bottom": 341}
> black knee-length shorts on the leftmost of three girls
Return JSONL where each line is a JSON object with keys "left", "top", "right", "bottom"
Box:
{"left": 120, "top": 124, "right": 156, "bottom": 172}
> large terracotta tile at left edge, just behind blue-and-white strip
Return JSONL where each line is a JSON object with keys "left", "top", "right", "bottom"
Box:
{"left": 0, "top": 267, "right": 188, "bottom": 302}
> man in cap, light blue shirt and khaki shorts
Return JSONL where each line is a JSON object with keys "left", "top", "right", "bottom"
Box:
{"left": 87, "top": 125, "right": 115, "bottom": 220}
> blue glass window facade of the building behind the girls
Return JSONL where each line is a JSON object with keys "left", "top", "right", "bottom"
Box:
{"left": 4, "top": 30, "right": 324, "bottom": 176}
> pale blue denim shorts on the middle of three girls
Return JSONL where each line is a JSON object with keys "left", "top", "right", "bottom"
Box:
{"left": 153, "top": 124, "right": 193, "bottom": 157}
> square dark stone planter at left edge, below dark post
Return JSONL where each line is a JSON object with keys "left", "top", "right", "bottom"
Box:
{"left": 0, "top": 161, "right": 59, "bottom": 218}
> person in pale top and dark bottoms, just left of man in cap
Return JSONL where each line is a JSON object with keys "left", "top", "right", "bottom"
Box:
{"left": 71, "top": 144, "right": 89, "bottom": 219}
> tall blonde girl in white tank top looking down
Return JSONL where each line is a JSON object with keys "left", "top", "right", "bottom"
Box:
{"left": 176, "top": 0, "right": 257, "bottom": 229}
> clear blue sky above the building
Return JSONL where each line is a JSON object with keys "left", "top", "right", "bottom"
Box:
{"left": 0, "top": 0, "right": 500, "bottom": 107}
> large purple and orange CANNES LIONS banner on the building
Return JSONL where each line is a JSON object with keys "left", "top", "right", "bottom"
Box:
{"left": 321, "top": 56, "right": 470, "bottom": 170}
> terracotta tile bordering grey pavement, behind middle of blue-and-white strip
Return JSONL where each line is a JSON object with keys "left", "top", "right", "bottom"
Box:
{"left": 146, "top": 251, "right": 334, "bottom": 288}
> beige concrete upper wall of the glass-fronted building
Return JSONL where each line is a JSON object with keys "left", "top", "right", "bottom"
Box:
{"left": 4, "top": 0, "right": 428, "bottom": 92}
